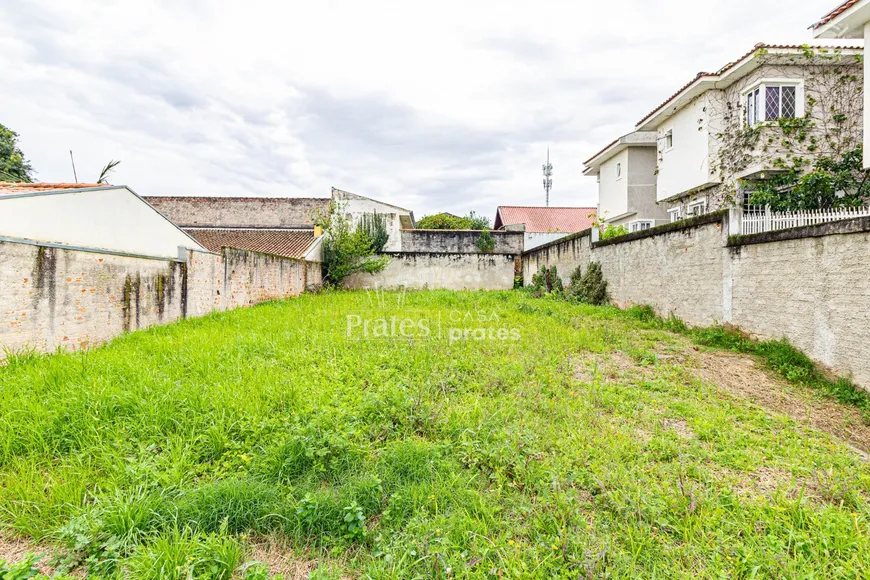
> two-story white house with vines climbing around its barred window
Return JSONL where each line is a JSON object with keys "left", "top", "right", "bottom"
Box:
{"left": 636, "top": 44, "right": 863, "bottom": 221}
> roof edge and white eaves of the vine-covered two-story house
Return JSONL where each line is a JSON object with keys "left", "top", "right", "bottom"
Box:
{"left": 637, "top": 43, "right": 864, "bottom": 131}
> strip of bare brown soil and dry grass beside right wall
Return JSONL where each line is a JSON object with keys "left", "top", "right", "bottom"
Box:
{"left": 697, "top": 352, "right": 870, "bottom": 459}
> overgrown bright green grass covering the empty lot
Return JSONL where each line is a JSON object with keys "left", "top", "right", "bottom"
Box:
{"left": 0, "top": 292, "right": 870, "bottom": 580}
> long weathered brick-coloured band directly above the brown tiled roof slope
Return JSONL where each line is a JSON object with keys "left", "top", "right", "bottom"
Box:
{"left": 144, "top": 196, "right": 330, "bottom": 229}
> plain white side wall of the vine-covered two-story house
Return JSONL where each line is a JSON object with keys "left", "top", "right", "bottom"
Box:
{"left": 656, "top": 95, "right": 717, "bottom": 201}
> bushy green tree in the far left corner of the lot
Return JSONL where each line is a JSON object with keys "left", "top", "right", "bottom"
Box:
{"left": 315, "top": 202, "right": 390, "bottom": 286}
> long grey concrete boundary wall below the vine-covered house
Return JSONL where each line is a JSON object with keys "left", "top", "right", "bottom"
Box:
{"left": 522, "top": 212, "right": 870, "bottom": 389}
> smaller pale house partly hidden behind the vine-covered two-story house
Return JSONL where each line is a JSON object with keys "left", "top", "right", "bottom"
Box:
{"left": 583, "top": 131, "right": 668, "bottom": 232}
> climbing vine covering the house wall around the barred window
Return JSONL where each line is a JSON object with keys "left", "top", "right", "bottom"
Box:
{"left": 699, "top": 47, "right": 870, "bottom": 210}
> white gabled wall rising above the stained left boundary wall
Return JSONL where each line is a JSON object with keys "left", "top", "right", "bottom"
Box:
{"left": 0, "top": 187, "right": 205, "bottom": 258}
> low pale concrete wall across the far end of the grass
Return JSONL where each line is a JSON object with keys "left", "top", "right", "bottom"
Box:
{"left": 344, "top": 252, "right": 515, "bottom": 290}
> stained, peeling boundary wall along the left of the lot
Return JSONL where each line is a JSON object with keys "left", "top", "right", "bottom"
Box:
{"left": 0, "top": 241, "right": 319, "bottom": 359}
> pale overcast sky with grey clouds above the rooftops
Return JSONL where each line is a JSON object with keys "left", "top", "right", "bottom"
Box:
{"left": 0, "top": 0, "right": 860, "bottom": 217}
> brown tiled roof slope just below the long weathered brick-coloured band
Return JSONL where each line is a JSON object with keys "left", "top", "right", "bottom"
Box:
{"left": 184, "top": 228, "right": 314, "bottom": 258}
